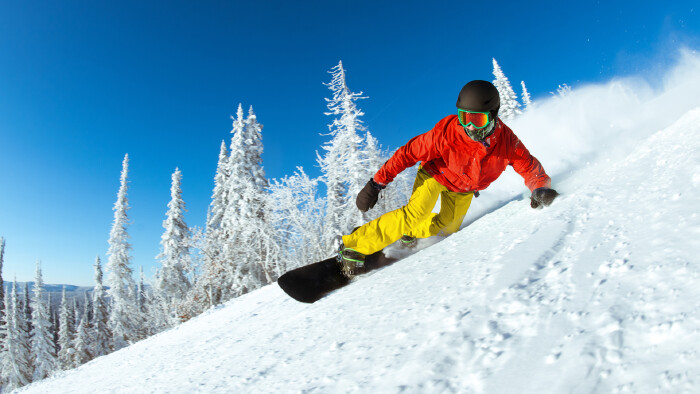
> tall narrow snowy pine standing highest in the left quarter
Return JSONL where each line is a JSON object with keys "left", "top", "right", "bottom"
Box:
{"left": 107, "top": 154, "right": 140, "bottom": 350}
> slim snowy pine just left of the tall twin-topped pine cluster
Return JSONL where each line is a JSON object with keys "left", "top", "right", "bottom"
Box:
{"left": 194, "top": 141, "right": 229, "bottom": 311}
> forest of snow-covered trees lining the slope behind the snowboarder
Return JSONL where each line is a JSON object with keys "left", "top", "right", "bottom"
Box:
{"left": 0, "top": 59, "right": 540, "bottom": 391}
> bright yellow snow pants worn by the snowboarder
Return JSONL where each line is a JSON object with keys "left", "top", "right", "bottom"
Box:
{"left": 343, "top": 168, "right": 474, "bottom": 255}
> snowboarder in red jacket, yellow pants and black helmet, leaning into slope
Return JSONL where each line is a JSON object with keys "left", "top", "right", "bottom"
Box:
{"left": 338, "top": 80, "right": 558, "bottom": 278}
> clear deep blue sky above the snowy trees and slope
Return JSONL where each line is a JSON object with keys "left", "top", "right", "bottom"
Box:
{"left": 0, "top": 0, "right": 700, "bottom": 285}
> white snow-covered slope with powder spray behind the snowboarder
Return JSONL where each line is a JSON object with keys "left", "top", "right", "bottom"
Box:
{"left": 16, "top": 53, "right": 700, "bottom": 393}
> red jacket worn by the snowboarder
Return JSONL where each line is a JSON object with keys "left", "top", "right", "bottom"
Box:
{"left": 374, "top": 115, "right": 551, "bottom": 193}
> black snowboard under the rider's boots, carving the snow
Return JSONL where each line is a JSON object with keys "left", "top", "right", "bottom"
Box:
{"left": 277, "top": 251, "right": 398, "bottom": 304}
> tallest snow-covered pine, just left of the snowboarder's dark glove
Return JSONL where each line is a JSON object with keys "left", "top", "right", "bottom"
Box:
{"left": 317, "top": 61, "right": 368, "bottom": 255}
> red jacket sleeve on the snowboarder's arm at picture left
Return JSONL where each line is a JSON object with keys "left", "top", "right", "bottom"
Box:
{"left": 374, "top": 122, "right": 442, "bottom": 185}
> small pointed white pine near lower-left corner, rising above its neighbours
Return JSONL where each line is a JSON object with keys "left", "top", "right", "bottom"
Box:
{"left": 31, "top": 263, "right": 57, "bottom": 382}
